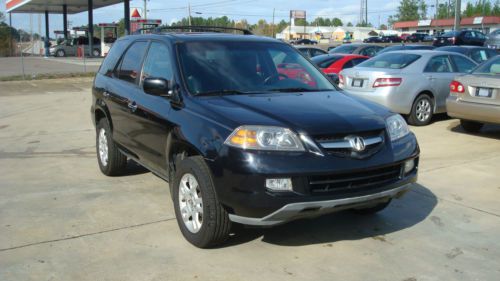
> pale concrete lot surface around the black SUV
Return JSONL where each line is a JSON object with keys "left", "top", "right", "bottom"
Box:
{"left": 0, "top": 78, "right": 500, "bottom": 281}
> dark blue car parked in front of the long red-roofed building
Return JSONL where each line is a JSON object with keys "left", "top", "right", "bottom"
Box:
{"left": 432, "top": 30, "right": 486, "bottom": 47}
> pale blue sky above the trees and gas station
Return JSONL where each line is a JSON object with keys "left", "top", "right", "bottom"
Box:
{"left": 0, "top": 0, "right": 473, "bottom": 36}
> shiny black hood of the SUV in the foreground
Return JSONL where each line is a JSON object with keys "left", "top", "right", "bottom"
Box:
{"left": 191, "top": 91, "right": 390, "bottom": 135}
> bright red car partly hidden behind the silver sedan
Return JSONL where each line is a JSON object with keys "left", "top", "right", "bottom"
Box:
{"left": 311, "top": 54, "right": 369, "bottom": 74}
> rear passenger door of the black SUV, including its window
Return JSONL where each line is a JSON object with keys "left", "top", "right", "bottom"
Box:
{"left": 107, "top": 41, "right": 149, "bottom": 156}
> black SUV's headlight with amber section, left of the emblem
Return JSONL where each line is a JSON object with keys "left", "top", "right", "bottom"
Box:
{"left": 224, "top": 126, "right": 305, "bottom": 151}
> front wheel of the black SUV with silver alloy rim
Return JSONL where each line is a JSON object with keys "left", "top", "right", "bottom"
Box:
{"left": 172, "top": 156, "right": 231, "bottom": 248}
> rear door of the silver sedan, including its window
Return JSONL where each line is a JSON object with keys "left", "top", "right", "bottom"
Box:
{"left": 424, "top": 55, "right": 455, "bottom": 111}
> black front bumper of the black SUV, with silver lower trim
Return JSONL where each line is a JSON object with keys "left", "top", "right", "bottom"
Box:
{"left": 207, "top": 131, "right": 419, "bottom": 225}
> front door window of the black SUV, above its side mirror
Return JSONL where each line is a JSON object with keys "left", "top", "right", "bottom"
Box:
{"left": 142, "top": 42, "right": 173, "bottom": 81}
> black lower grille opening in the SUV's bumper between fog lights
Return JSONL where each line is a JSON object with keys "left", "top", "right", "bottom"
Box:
{"left": 308, "top": 164, "right": 401, "bottom": 195}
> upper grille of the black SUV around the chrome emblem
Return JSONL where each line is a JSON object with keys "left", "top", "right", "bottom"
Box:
{"left": 314, "top": 130, "right": 385, "bottom": 159}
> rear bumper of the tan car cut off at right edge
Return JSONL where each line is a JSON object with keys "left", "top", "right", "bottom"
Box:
{"left": 446, "top": 96, "right": 500, "bottom": 124}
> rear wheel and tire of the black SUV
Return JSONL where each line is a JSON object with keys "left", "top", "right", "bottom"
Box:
{"left": 96, "top": 118, "right": 127, "bottom": 176}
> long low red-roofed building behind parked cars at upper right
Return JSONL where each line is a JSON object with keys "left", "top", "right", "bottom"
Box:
{"left": 393, "top": 16, "right": 500, "bottom": 34}
